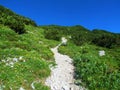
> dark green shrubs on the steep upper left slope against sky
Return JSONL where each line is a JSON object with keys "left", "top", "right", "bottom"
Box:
{"left": 0, "top": 6, "right": 36, "bottom": 34}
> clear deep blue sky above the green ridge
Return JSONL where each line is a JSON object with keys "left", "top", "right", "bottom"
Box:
{"left": 0, "top": 0, "right": 120, "bottom": 33}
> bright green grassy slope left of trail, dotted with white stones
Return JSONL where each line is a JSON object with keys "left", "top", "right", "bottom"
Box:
{"left": 0, "top": 25, "right": 58, "bottom": 90}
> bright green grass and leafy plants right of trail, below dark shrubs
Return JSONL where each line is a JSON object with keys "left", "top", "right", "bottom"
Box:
{"left": 59, "top": 43, "right": 120, "bottom": 90}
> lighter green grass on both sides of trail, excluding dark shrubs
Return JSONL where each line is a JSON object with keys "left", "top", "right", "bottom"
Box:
{"left": 0, "top": 25, "right": 120, "bottom": 90}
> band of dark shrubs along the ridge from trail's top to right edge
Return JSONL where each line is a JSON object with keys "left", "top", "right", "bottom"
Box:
{"left": 40, "top": 25, "right": 120, "bottom": 48}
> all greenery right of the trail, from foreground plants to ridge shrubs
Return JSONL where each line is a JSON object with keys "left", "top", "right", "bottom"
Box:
{"left": 42, "top": 25, "right": 120, "bottom": 90}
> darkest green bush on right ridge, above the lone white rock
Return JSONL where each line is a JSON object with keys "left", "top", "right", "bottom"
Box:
{"left": 92, "top": 30, "right": 116, "bottom": 48}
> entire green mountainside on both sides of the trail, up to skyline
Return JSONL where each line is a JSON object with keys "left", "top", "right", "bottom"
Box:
{"left": 0, "top": 6, "right": 120, "bottom": 90}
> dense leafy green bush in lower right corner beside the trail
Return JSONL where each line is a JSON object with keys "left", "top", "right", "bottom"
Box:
{"left": 74, "top": 56, "right": 120, "bottom": 90}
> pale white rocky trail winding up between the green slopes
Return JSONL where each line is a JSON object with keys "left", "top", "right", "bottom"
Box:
{"left": 45, "top": 45, "right": 84, "bottom": 90}
